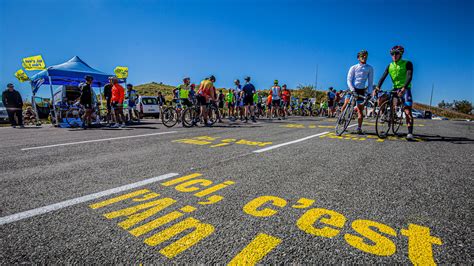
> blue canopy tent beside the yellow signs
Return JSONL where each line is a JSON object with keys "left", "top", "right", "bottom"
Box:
{"left": 30, "top": 56, "right": 126, "bottom": 122}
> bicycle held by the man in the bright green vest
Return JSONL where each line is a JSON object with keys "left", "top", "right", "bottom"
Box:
{"left": 375, "top": 91, "right": 404, "bottom": 139}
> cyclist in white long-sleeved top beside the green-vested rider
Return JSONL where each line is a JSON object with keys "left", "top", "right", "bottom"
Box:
{"left": 341, "top": 50, "right": 374, "bottom": 134}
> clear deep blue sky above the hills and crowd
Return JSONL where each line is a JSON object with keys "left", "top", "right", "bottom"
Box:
{"left": 0, "top": 0, "right": 474, "bottom": 104}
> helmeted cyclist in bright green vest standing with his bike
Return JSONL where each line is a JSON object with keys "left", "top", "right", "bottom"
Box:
{"left": 374, "top": 45, "right": 413, "bottom": 140}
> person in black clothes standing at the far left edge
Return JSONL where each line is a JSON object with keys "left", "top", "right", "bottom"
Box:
{"left": 2, "top": 83, "right": 25, "bottom": 128}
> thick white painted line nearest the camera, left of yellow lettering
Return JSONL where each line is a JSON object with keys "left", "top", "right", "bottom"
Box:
{"left": 0, "top": 173, "right": 178, "bottom": 225}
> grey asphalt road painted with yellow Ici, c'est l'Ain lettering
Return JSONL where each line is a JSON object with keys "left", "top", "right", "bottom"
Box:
{"left": 0, "top": 117, "right": 474, "bottom": 264}
